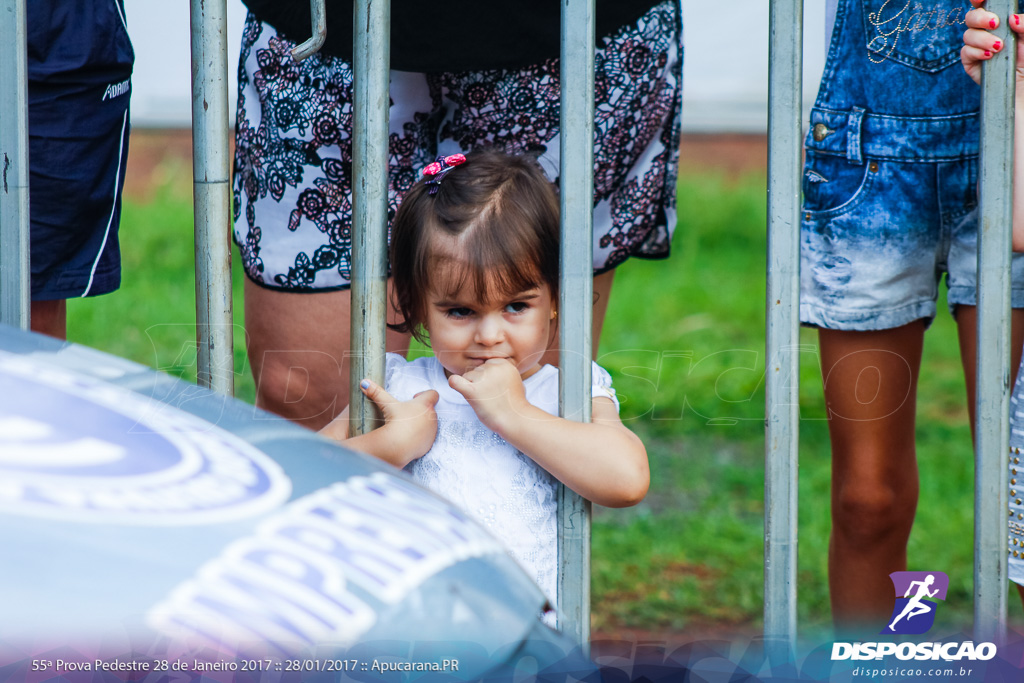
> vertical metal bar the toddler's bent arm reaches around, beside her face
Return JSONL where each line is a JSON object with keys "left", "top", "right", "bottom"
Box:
{"left": 558, "top": 0, "right": 596, "bottom": 647}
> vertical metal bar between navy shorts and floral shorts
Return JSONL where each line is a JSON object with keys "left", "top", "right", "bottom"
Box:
{"left": 191, "top": 0, "right": 234, "bottom": 395}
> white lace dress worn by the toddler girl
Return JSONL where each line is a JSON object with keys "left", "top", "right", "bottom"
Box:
{"left": 385, "top": 353, "right": 618, "bottom": 605}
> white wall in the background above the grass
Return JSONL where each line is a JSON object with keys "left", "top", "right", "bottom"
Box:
{"left": 125, "top": 0, "right": 825, "bottom": 132}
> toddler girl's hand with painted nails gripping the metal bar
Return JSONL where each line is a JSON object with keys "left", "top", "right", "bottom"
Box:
{"left": 352, "top": 380, "right": 439, "bottom": 467}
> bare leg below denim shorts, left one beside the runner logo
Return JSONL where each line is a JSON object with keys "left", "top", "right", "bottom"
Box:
{"left": 819, "top": 321, "right": 925, "bottom": 629}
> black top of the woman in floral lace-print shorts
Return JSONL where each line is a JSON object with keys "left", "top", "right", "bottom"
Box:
{"left": 243, "top": 0, "right": 663, "bottom": 72}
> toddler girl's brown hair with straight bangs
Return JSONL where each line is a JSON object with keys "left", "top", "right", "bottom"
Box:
{"left": 389, "top": 150, "right": 559, "bottom": 343}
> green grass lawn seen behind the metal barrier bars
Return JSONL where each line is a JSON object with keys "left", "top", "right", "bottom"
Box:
{"left": 69, "top": 152, "right": 1021, "bottom": 635}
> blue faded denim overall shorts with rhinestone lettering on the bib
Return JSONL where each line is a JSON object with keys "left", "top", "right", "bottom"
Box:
{"left": 800, "top": 0, "right": 1024, "bottom": 330}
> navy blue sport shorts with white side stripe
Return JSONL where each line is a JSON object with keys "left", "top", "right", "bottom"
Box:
{"left": 28, "top": 0, "right": 134, "bottom": 301}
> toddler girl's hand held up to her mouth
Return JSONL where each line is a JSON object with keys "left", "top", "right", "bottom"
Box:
{"left": 449, "top": 358, "right": 529, "bottom": 437}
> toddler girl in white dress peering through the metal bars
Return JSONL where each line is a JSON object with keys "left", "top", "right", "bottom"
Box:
{"left": 323, "top": 152, "right": 649, "bottom": 604}
